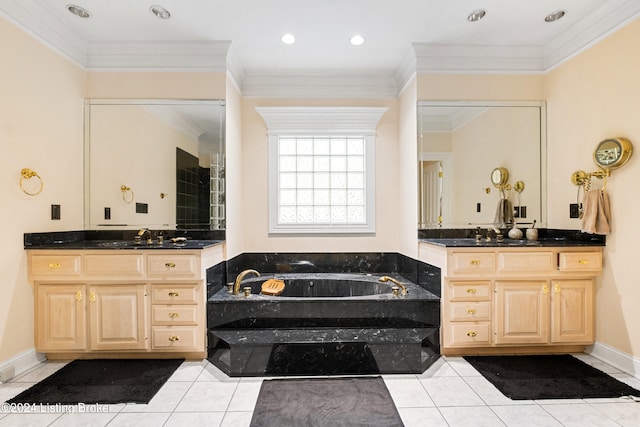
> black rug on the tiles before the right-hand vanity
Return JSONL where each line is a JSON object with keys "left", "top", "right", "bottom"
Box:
{"left": 465, "top": 354, "right": 640, "bottom": 400}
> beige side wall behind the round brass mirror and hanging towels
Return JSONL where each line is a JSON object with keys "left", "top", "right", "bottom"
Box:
{"left": 545, "top": 20, "right": 640, "bottom": 357}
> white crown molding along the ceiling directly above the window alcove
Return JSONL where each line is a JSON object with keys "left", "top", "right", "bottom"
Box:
{"left": 242, "top": 71, "right": 398, "bottom": 98}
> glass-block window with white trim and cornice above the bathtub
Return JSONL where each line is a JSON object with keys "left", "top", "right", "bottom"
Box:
{"left": 257, "top": 107, "right": 386, "bottom": 233}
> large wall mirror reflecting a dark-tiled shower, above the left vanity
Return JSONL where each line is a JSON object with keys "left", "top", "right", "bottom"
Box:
{"left": 85, "top": 99, "right": 226, "bottom": 230}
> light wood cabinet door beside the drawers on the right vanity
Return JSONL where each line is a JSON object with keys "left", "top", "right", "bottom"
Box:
{"left": 495, "top": 280, "right": 549, "bottom": 344}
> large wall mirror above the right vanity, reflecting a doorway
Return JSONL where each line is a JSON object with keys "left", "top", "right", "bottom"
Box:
{"left": 417, "top": 101, "right": 546, "bottom": 229}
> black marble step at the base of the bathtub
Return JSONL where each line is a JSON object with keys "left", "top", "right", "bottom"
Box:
{"left": 209, "top": 328, "right": 438, "bottom": 376}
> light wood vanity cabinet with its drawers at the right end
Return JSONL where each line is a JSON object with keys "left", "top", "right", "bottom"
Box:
{"left": 27, "top": 242, "right": 224, "bottom": 359}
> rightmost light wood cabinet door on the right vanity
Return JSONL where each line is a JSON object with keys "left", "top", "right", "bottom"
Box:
{"left": 551, "top": 279, "right": 593, "bottom": 344}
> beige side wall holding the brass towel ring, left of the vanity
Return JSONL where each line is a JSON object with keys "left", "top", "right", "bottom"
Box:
{"left": 0, "top": 19, "right": 86, "bottom": 363}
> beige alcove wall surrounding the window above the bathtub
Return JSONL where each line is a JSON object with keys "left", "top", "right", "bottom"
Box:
{"left": 241, "top": 98, "right": 400, "bottom": 252}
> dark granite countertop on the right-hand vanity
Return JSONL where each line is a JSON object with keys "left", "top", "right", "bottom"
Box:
{"left": 418, "top": 237, "right": 605, "bottom": 248}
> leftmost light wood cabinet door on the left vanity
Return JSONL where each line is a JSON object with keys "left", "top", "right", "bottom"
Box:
{"left": 35, "top": 284, "right": 87, "bottom": 351}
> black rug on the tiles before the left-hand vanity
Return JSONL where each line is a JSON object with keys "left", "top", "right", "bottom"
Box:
{"left": 8, "top": 359, "right": 184, "bottom": 405}
